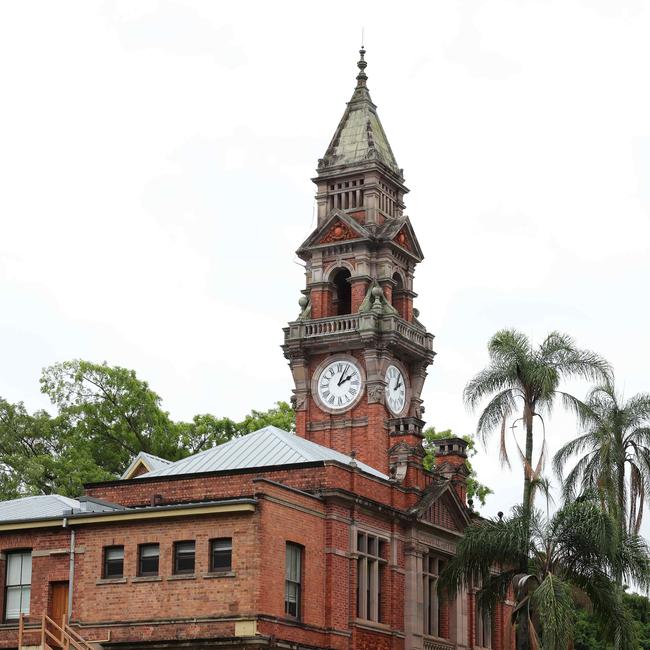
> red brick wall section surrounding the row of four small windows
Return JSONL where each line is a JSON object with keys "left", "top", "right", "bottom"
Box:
{"left": 72, "top": 513, "right": 259, "bottom": 624}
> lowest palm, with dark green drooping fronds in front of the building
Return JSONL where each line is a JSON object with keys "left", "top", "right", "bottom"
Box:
{"left": 440, "top": 496, "right": 650, "bottom": 650}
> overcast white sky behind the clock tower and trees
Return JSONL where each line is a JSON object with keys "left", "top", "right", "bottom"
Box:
{"left": 0, "top": 0, "right": 650, "bottom": 513}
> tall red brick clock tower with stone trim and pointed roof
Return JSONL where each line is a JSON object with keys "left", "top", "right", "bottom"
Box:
{"left": 283, "top": 48, "right": 434, "bottom": 474}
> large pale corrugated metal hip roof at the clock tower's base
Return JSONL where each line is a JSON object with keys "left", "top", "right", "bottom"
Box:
{"left": 137, "top": 426, "right": 388, "bottom": 479}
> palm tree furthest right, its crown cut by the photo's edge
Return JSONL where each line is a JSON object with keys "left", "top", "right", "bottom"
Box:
{"left": 553, "top": 381, "right": 650, "bottom": 537}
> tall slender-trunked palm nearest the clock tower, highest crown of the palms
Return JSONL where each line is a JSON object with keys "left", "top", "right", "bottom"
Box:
{"left": 464, "top": 329, "right": 610, "bottom": 540}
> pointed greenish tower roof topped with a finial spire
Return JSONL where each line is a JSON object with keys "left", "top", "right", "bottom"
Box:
{"left": 318, "top": 46, "right": 403, "bottom": 178}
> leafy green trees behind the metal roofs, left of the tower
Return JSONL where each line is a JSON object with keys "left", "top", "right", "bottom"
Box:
{"left": 0, "top": 360, "right": 295, "bottom": 499}
